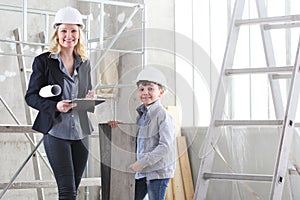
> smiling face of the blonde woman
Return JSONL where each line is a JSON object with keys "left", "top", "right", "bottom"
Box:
{"left": 57, "top": 24, "right": 80, "bottom": 49}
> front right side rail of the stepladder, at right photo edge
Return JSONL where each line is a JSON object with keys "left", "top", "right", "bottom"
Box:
{"left": 270, "top": 37, "right": 300, "bottom": 200}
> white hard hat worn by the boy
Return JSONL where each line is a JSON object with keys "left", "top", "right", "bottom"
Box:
{"left": 136, "top": 67, "right": 167, "bottom": 87}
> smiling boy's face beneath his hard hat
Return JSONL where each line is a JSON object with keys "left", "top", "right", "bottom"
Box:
{"left": 138, "top": 83, "right": 164, "bottom": 106}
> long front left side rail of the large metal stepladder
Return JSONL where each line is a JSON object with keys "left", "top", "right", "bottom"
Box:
{"left": 194, "top": 0, "right": 245, "bottom": 200}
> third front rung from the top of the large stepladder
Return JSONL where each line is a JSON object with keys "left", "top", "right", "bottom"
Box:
{"left": 215, "top": 120, "right": 283, "bottom": 126}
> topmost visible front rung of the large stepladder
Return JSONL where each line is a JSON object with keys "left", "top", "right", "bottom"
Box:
{"left": 235, "top": 15, "right": 300, "bottom": 26}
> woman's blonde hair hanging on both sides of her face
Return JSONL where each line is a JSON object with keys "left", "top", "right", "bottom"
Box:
{"left": 47, "top": 26, "right": 87, "bottom": 60}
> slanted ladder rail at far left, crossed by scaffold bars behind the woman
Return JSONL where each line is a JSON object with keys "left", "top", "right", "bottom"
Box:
{"left": 13, "top": 29, "right": 45, "bottom": 200}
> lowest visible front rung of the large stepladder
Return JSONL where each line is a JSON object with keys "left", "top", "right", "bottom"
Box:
{"left": 203, "top": 173, "right": 273, "bottom": 182}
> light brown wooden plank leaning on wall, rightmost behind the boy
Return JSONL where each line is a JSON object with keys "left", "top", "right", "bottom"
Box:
{"left": 177, "top": 136, "right": 195, "bottom": 200}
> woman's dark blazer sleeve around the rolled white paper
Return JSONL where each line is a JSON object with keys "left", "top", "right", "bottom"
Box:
{"left": 25, "top": 57, "right": 61, "bottom": 118}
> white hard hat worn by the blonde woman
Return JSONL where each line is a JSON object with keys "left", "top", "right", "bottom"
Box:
{"left": 53, "top": 7, "right": 84, "bottom": 29}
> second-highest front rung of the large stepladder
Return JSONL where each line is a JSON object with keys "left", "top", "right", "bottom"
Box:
{"left": 225, "top": 66, "right": 294, "bottom": 75}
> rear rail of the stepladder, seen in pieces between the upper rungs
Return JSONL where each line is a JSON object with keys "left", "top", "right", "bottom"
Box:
{"left": 256, "top": 0, "right": 284, "bottom": 119}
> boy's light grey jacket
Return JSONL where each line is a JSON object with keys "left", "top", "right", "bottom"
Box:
{"left": 136, "top": 100, "right": 176, "bottom": 180}
